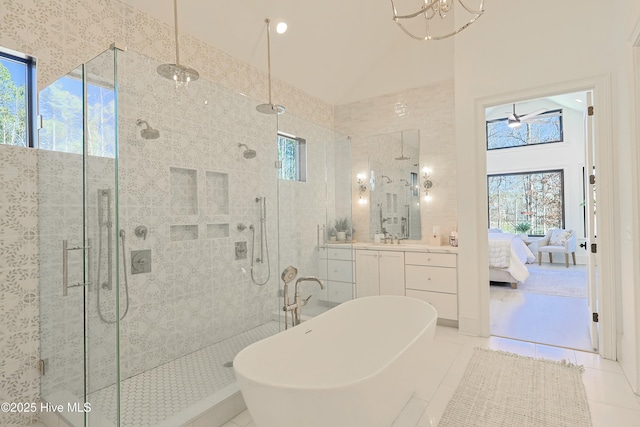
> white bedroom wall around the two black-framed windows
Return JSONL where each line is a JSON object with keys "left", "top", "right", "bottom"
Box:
{"left": 487, "top": 99, "right": 587, "bottom": 264}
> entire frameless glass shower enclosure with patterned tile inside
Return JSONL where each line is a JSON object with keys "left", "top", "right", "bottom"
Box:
{"left": 38, "top": 47, "right": 353, "bottom": 427}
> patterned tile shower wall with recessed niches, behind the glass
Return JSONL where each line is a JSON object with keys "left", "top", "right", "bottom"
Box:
{"left": 118, "top": 50, "right": 278, "bottom": 378}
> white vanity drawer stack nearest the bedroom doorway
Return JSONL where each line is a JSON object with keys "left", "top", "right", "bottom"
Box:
{"left": 405, "top": 252, "right": 458, "bottom": 321}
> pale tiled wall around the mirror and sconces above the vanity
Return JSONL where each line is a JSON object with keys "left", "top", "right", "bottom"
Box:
{"left": 335, "top": 81, "right": 457, "bottom": 244}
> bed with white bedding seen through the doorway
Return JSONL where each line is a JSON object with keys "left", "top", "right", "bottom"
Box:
{"left": 489, "top": 232, "right": 536, "bottom": 289}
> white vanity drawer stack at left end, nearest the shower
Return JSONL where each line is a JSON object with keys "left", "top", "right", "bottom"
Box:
{"left": 318, "top": 245, "right": 354, "bottom": 305}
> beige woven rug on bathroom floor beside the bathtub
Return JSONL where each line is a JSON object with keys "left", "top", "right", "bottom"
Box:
{"left": 438, "top": 349, "right": 592, "bottom": 427}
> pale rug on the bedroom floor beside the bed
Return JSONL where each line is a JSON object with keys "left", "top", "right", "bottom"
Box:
{"left": 491, "top": 264, "right": 587, "bottom": 298}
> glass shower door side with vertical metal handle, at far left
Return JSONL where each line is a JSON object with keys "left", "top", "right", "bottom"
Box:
{"left": 38, "top": 46, "right": 118, "bottom": 426}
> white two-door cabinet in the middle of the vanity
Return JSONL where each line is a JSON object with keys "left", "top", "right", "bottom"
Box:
{"left": 356, "top": 249, "right": 405, "bottom": 298}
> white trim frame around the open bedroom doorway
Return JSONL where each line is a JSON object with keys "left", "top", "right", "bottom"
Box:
{"left": 475, "top": 75, "right": 618, "bottom": 360}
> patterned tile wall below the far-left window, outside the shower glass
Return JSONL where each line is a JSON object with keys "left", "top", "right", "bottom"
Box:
{"left": 0, "top": 146, "right": 40, "bottom": 426}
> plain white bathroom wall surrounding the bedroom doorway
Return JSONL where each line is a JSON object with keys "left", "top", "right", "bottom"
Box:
{"left": 455, "top": 0, "right": 640, "bottom": 390}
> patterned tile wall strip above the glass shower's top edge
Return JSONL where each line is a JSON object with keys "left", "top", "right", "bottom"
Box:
{"left": 0, "top": 0, "right": 333, "bottom": 129}
